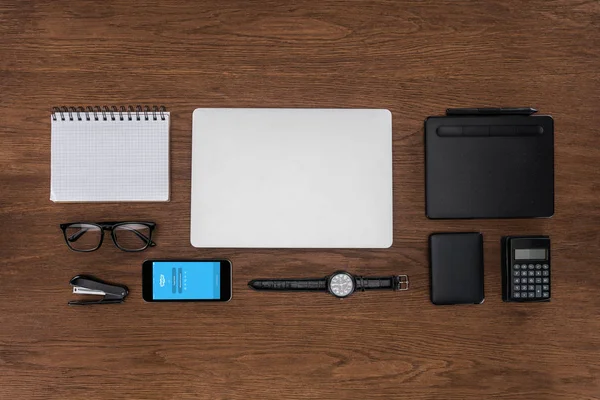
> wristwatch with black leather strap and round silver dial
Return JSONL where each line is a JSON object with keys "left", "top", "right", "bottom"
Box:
{"left": 248, "top": 271, "right": 408, "bottom": 298}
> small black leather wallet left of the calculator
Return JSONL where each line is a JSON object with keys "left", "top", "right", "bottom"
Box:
{"left": 429, "top": 233, "right": 485, "bottom": 305}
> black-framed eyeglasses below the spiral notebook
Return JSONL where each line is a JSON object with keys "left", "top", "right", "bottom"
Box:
{"left": 60, "top": 222, "right": 156, "bottom": 252}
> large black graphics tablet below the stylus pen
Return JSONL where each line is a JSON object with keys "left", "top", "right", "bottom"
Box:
{"left": 425, "top": 115, "right": 554, "bottom": 219}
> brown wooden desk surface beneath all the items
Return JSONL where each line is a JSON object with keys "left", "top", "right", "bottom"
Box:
{"left": 0, "top": 0, "right": 600, "bottom": 400}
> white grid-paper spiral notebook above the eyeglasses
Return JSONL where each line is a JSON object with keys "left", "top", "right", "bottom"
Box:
{"left": 50, "top": 106, "right": 170, "bottom": 202}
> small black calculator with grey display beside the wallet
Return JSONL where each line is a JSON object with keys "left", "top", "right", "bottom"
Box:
{"left": 502, "top": 236, "right": 552, "bottom": 302}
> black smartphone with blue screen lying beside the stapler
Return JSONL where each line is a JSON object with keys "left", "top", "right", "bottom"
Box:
{"left": 142, "top": 260, "right": 231, "bottom": 301}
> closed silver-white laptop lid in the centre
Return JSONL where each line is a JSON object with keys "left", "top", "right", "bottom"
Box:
{"left": 190, "top": 108, "right": 392, "bottom": 248}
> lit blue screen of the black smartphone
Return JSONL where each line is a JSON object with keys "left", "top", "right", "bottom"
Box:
{"left": 152, "top": 261, "right": 221, "bottom": 300}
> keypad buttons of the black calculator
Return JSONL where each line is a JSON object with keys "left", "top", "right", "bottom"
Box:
{"left": 510, "top": 262, "right": 550, "bottom": 301}
